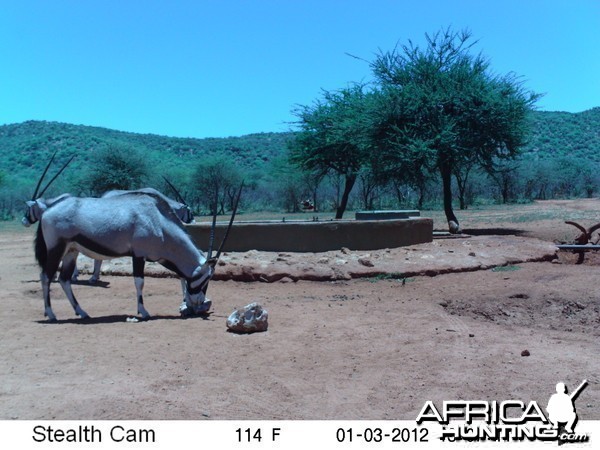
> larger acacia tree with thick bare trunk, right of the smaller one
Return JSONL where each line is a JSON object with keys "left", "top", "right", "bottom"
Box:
{"left": 371, "top": 28, "right": 539, "bottom": 232}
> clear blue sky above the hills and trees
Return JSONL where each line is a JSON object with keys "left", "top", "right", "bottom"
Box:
{"left": 0, "top": 0, "right": 600, "bottom": 138}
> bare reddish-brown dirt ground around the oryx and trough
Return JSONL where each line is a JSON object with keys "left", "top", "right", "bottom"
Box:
{"left": 0, "top": 201, "right": 600, "bottom": 420}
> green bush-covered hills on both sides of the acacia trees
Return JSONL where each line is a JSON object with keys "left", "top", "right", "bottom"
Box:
{"left": 0, "top": 107, "right": 600, "bottom": 176}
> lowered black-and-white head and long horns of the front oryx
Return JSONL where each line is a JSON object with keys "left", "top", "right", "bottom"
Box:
{"left": 180, "top": 183, "right": 244, "bottom": 314}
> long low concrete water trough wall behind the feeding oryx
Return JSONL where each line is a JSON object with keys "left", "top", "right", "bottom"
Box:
{"left": 186, "top": 217, "right": 433, "bottom": 252}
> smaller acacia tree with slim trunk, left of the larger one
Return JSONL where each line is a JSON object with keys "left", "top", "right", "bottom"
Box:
{"left": 290, "top": 84, "right": 372, "bottom": 219}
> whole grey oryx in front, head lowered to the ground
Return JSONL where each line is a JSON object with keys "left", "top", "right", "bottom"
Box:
{"left": 35, "top": 187, "right": 241, "bottom": 321}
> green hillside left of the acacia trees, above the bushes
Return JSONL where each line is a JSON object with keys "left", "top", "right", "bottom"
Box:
{"left": 0, "top": 121, "right": 290, "bottom": 181}
